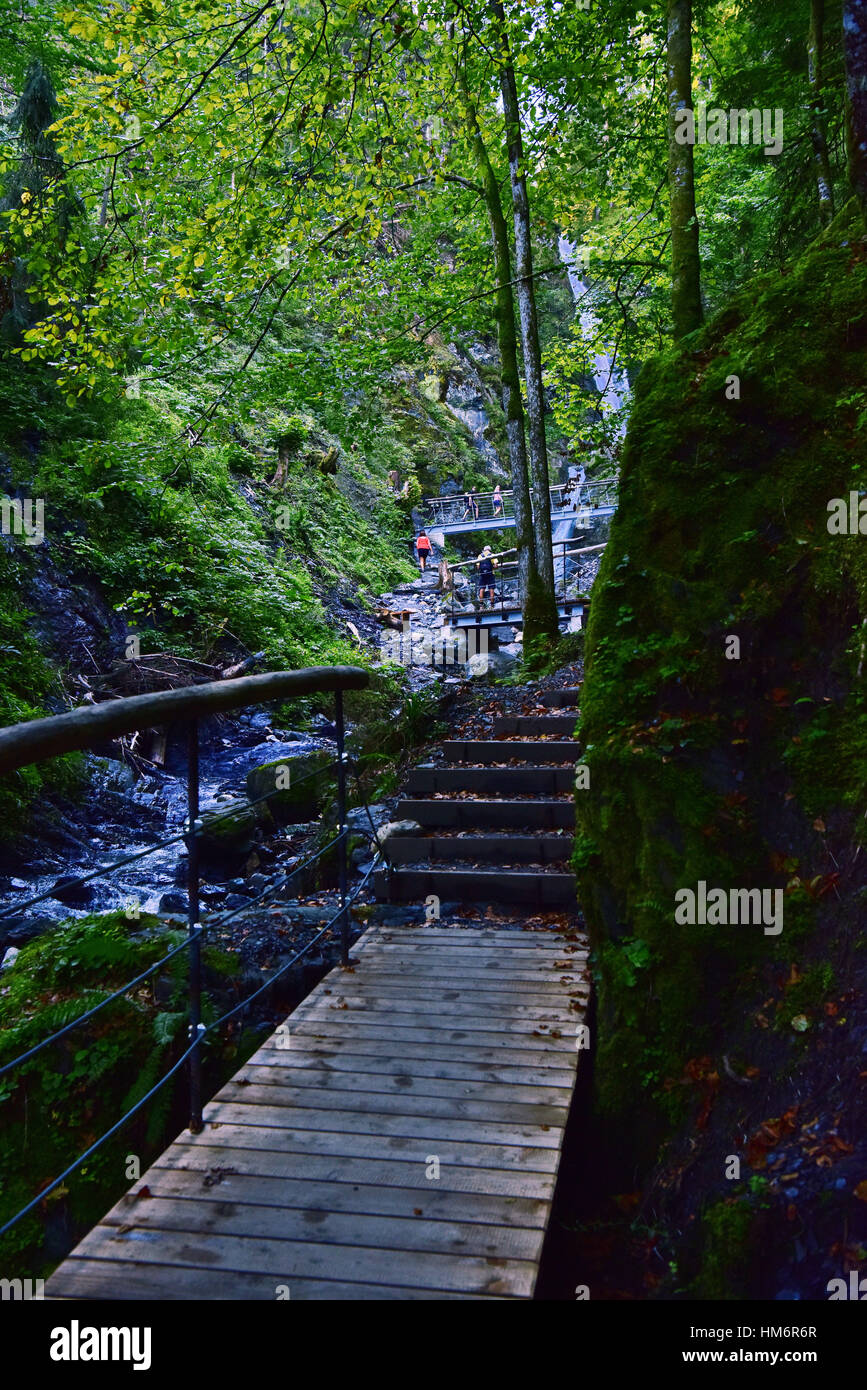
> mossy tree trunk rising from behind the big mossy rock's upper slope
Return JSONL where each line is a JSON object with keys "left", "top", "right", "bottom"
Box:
{"left": 667, "top": 0, "right": 704, "bottom": 338}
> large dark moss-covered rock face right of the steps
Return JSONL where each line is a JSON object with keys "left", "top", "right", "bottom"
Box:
{"left": 574, "top": 209, "right": 867, "bottom": 1144}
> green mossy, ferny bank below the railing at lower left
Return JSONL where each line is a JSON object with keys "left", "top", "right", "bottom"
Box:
{"left": 0, "top": 913, "right": 233, "bottom": 1275}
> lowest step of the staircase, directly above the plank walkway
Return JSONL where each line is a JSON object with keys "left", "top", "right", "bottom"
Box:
{"left": 374, "top": 869, "right": 575, "bottom": 908}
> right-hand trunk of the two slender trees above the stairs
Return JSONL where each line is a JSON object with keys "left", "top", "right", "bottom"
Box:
{"left": 490, "top": 0, "right": 559, "bottom": 642}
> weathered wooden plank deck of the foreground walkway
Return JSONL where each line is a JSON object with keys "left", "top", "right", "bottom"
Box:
{"left": 46, "top": 927, "right": 589, "bottom": 1301}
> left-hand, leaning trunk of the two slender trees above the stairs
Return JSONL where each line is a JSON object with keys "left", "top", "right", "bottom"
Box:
{"left": 457, "top": 58, "right": 539, "bottom": 641}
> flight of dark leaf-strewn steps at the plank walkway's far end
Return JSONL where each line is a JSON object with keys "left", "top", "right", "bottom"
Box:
{"left": 374, "top": 688, "right": 578, "bottom": 908}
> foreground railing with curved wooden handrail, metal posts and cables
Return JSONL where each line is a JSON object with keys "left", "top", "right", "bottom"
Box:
{"left": 0, "top": 666, "right": 369, "bottom": 1236}
